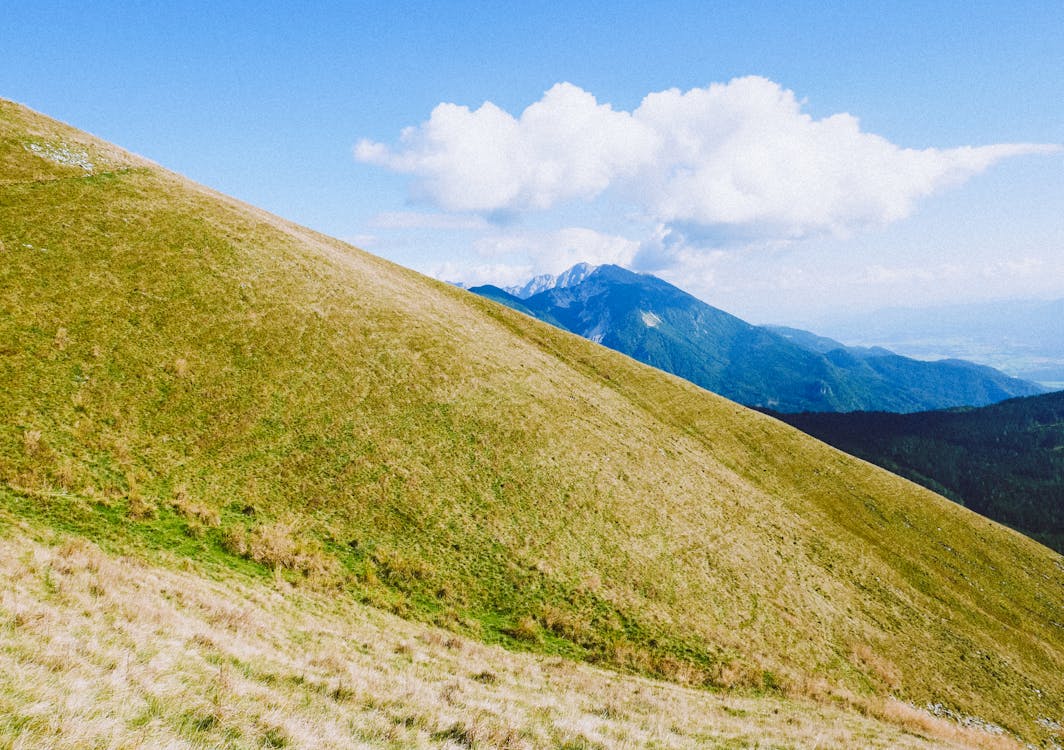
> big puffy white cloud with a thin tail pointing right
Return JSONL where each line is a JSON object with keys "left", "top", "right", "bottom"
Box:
{"left": 355, "top": 77, "right": 1060, "bottom": 238}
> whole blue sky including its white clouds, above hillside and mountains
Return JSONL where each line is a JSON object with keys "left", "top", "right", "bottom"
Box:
{"left": 0, "top": 0, "right": 1064, "bottom": 323}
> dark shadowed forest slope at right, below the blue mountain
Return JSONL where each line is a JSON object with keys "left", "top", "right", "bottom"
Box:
{"left": 777, "top": 391, "right": 1064, "bottom": 552}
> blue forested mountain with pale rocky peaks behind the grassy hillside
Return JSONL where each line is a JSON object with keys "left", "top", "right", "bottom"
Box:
{"left": 470, "top": 264, "right": 1045, "bottom": 412}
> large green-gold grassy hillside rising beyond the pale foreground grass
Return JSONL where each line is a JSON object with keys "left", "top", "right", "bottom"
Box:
{"left": 0, "top": 97, "right": 1064, "bottom": 740}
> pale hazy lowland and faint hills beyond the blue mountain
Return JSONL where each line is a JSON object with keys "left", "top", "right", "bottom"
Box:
{"left": 819, "top": 300, "right": 1064, "bottom": 387}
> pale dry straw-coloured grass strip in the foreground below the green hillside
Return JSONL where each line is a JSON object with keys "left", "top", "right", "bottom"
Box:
{"left": 0, "top": 531, "right": 1013, "bottom": 750}
